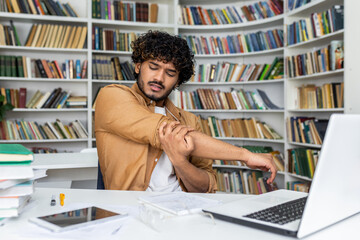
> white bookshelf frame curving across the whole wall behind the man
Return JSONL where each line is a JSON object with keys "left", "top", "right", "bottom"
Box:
{"left": 0, "top": 0, "right": 354, "bottom": 193}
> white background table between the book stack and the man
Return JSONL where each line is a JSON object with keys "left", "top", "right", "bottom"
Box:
{"left": 32, "top": 153, "right": 98, "bottom": 189}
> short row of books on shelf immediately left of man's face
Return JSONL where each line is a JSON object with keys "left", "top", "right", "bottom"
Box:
{"left": 92, "top": 55, "right": 135, "bottom": 80}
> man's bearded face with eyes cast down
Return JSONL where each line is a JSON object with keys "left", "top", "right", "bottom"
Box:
{"left": 135, "top": 59, "right": 179, "bottom": 106}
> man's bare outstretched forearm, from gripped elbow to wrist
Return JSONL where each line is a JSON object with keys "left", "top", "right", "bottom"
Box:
{"left": 188, "top": 131, "right": 252, "bottom": 162}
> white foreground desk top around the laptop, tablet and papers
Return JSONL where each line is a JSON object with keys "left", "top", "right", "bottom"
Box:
{"left": 0, "top": 188, "right": 360, "bottom": 240}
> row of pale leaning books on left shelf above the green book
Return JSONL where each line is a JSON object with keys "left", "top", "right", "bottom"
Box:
{"left": 0, "top": 119, "right": 88, "bottom": 140}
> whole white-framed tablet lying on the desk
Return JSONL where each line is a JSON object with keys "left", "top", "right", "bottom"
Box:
{"left": 29, "top": 206, "right": 127, "bottom": 232}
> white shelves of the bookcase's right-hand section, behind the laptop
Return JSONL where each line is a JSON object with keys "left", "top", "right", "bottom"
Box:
{"left": 284, "top": 0, "right": 349, "bottom": 189}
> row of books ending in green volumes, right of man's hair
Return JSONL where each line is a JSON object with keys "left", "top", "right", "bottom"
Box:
{"left": 190, "top": 57, "right": 284, "bottom": 82}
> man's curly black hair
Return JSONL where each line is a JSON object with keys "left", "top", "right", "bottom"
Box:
{"left": 131, "top": 30, "right": 195, "bottom": 86}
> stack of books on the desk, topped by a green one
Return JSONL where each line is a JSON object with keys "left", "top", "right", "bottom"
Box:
{"left": 0, "top": 144, "right": 46, "bottom": 219}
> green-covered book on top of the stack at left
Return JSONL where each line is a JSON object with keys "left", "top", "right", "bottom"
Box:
{"left": 0, "top": 143, "right": 34, "bottom": 162}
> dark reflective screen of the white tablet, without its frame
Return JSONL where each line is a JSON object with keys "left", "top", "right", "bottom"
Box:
{"left": 38, "top": 206, "right": 120, "bottom": 228}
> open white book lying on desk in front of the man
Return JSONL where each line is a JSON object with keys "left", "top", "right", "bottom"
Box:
{"left": 139, "top": 192, "right": 220, "bottom": 215}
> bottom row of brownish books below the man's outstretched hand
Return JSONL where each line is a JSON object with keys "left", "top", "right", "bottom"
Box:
{"left": 216, "top": 169, "right": 278, "bottom": 194}
